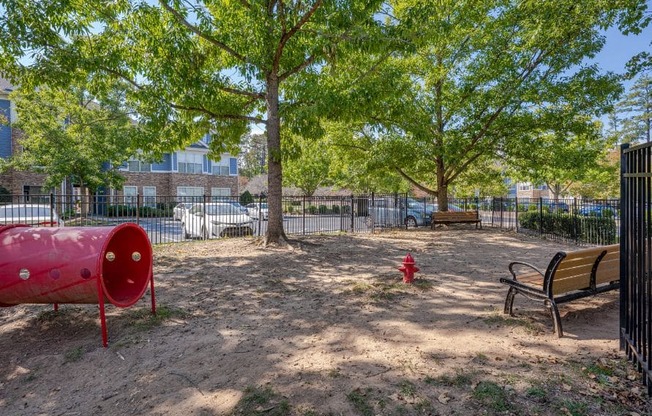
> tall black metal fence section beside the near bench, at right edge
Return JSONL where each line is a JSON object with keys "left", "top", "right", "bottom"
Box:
{"left": 620, "top": 143, "right": 652, "bottom": 394}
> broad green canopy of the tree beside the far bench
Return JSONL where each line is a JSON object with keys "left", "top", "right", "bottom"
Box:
{"left": 324, "top": 0, "right": 646, "bottom": 210}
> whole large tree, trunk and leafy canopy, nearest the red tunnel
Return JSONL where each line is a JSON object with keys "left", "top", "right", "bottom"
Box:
{"left": 0, "top": 0, "right": 382, "bottom": 242}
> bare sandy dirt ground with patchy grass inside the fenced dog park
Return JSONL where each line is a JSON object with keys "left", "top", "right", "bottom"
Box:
{"left": 0, "top": 226, "right": 652, "bottom": 415}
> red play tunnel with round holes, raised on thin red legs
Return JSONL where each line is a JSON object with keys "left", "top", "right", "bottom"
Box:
{"left": 0, "top": 223, "right": 154, "bottom": 346}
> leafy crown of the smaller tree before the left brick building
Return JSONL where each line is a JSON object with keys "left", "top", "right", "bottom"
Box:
{"left": 4, "top": 86, "right": 146, "bottom": 190}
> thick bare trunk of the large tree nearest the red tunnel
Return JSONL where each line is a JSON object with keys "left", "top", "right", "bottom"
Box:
{"left": 265, "top": 74, "right": 284, "bottom": 244}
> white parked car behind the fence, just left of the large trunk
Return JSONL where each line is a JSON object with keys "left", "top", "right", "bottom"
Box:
{"left": 183, "top": 202, "right": 254, "bottom": 238}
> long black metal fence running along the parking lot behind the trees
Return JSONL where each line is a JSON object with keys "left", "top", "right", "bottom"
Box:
{"left": 0, "top": 194, "right": 620, "bottom": 245}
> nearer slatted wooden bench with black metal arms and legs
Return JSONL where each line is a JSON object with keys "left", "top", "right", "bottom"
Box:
{"left": 500, "top": 244, "right": 620, "bottom": 337}
